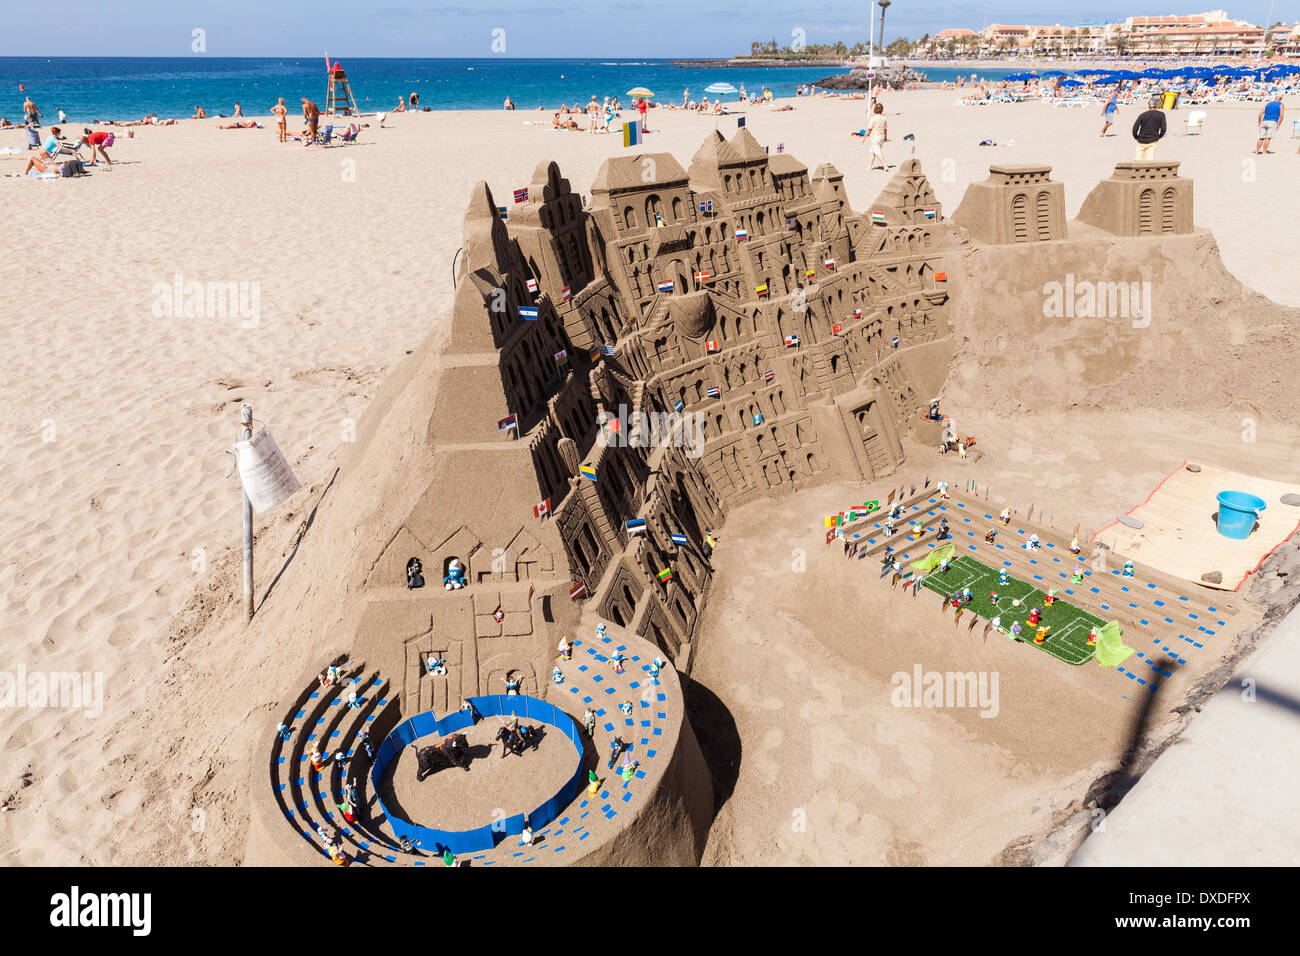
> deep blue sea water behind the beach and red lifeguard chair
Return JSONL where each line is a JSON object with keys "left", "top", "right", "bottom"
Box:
{"left": 0, "top": 56, "right": 1005, "bottom": 124}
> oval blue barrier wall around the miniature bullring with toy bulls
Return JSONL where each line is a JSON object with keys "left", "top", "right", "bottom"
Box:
{"left": 371, "top": 693, "right": 586, "bottom": 855}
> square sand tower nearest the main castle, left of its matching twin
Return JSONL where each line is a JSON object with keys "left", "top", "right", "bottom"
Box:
{"left": 953, "top": 165, "right": 1066, "bottom": 245}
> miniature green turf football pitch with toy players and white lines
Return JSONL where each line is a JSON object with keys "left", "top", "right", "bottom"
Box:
{"left": 922, "top": 554, "right": 1106, "bottom": 663}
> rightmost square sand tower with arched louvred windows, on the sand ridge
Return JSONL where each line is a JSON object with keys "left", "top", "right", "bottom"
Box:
{"left": 1078, "top": 160, "right": 1195, "bottom": 235}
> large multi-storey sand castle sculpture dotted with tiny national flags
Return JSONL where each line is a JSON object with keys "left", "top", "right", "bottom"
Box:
{"left": 245, "top": 129, "right": 1190, "bottom": 862}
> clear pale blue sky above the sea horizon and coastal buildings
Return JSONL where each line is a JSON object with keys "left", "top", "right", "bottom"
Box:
{"left": 0, "top": 0, "right": 1300, "bottom": 59}
